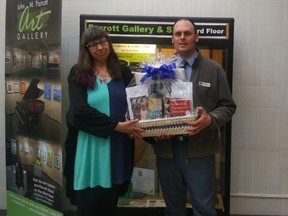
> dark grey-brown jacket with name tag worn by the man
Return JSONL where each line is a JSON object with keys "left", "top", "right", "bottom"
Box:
{"left": 153, "top": 54, "right": 236, "bottom": 158}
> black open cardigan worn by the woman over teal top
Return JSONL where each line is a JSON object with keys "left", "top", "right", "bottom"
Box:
{"left": 64, "top": 65, "right": 133, "bottom": 205}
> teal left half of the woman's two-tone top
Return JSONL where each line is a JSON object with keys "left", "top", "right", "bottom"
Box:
{"left": 74, "top": 78, "right": 111, "bottom": 190}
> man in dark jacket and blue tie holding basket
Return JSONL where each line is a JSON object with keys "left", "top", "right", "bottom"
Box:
{"left": 154, "top": 19, "right": 236, "bottom": 216}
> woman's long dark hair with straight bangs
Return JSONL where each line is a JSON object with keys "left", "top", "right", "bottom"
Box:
{"left": 76, "top": 26, "right": 121, "bottom": 89}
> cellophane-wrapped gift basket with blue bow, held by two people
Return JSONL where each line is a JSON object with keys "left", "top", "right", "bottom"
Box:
{"left": 126, "top": 54, "right": 197, "bottom": 137}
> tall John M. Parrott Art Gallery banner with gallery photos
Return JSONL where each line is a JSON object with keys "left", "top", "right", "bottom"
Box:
{"left": 5, "top": 0, "right": 63, "bottom": 216}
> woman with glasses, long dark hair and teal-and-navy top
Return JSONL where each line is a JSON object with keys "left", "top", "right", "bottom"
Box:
{"left": 64, "top": 26, "right": 142, "bottom": 216}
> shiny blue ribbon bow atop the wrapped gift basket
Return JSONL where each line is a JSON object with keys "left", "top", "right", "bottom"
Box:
{"left": 140, "top": 63, "right": 176, "bottom": 84}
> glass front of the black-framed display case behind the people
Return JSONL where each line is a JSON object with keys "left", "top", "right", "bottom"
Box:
{"left": 114, "top": 44, "right": 227, "bottom": 211}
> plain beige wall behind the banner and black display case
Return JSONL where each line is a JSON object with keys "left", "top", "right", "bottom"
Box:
{"left": 0, "top": 0, "right": 288, "bottom": 215}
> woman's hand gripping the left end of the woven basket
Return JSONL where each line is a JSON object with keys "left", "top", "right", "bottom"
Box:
{"left": 115, "top": 119, "right": 144, "bottom": 139}
